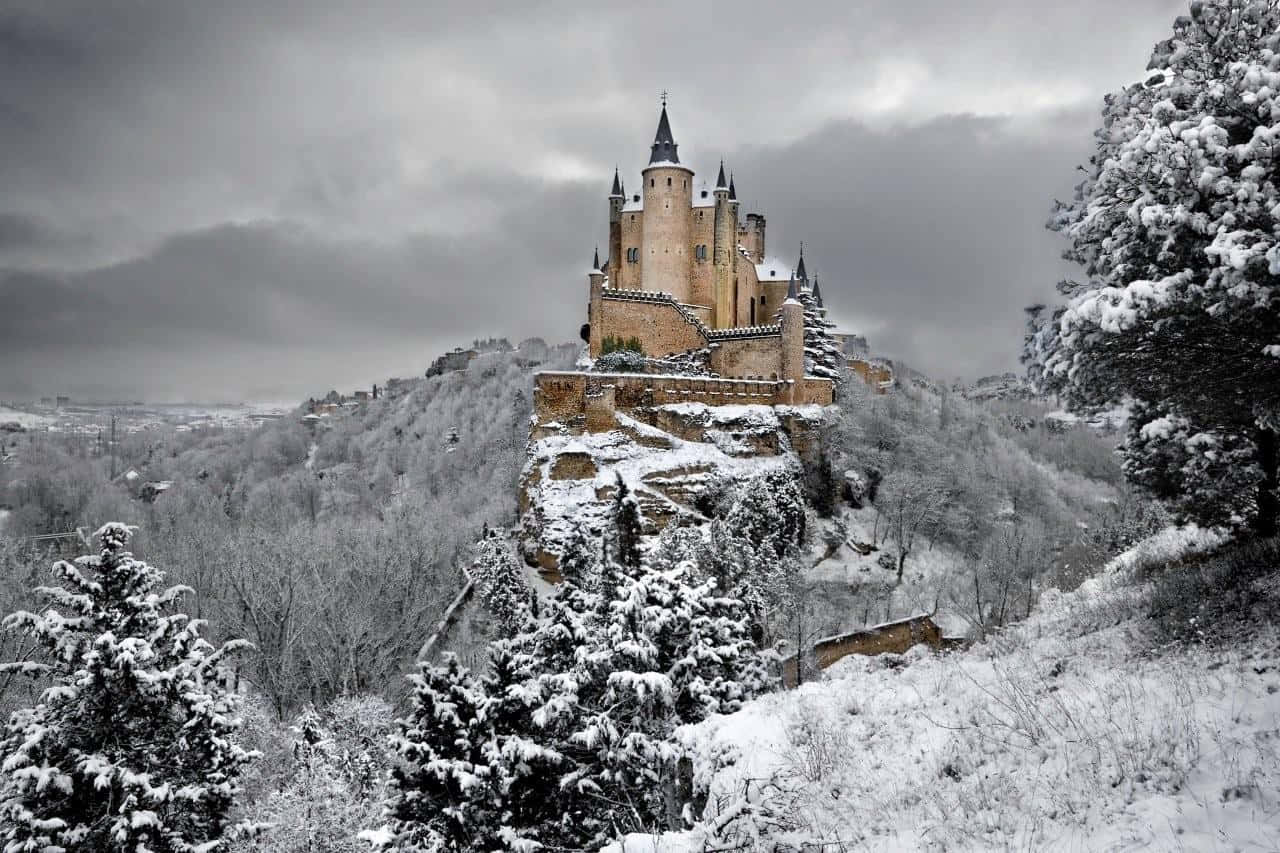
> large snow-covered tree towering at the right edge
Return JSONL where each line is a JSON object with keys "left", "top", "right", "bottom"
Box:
{"left": 1024, "top": 0, "right": 1280, "bottom": 535}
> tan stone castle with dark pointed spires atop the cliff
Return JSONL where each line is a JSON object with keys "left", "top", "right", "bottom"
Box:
{"left": 538, "top": 104, "right": 833, "bottom": 418}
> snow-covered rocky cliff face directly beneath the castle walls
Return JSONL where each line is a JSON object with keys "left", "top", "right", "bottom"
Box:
{"left": 520, "top": 403, "right": 823, "bottom": 579}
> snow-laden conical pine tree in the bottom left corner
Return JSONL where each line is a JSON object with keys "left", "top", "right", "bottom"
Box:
{"left": 0, "top": 524, "right": 252, "bottom": 853}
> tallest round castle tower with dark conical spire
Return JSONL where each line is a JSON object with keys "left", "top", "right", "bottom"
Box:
{"left": 640, "top": 105, "right": 694, "bottom": 302}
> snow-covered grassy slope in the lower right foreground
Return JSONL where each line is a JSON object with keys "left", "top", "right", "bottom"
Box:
{"left": 612, "top": 530, "right": 1280, "bottom": 852}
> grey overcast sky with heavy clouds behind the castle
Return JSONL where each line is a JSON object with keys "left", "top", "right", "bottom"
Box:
{"left": 0, "top": 0, "right": 1185, "bottom": 400}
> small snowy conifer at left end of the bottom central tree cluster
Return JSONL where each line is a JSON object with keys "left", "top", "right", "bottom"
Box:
{"left": 362, "top": 654, "right": 502, "bottom": 853}
